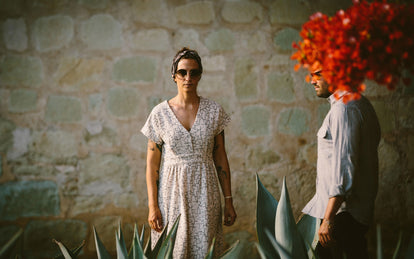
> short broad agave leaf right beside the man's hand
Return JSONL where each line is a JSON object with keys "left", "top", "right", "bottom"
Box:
{"left": 296, "top": 214, "right": 321, "bottom": 256}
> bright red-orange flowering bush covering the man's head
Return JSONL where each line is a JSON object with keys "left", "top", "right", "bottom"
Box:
{"left": 291, "top": 0, "right": 414, "bottom": 99}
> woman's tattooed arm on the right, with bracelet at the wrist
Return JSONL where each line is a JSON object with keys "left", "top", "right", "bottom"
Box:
{"left": 213, "top": 131, "right": 237, "bottom": 226}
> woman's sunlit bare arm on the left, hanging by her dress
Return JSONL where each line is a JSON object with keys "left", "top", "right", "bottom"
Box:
{"left": 146, "top": 140, "right": 163, "bottom": 232}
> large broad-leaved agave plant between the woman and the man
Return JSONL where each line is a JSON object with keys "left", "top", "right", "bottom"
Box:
{"left": 256, "top": 175, "right": 320, "bottom": 259}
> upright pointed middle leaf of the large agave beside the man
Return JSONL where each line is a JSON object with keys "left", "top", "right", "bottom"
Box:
{"left": 275, "top": 177, "right": 308, "bottom": 259}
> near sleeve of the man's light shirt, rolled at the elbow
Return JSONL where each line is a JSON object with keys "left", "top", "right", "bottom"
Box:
{"left": 328, "top": 105, "right": 360, "bottom": 199}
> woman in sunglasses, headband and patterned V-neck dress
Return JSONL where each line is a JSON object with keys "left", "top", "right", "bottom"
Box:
{"left": 141, "top": 48, "right": 236, "bottom": 258}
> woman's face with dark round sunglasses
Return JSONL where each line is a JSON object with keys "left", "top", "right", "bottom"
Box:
{"left": 174, "top": 59, "right": 201, "bottom": 92}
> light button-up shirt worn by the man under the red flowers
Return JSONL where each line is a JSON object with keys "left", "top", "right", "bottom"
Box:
{"left": 303, "top": 93, "right": 381, "bottom": 225}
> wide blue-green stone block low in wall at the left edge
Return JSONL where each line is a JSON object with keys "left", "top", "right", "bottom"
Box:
{"left": 0, "top": 181, "right": 60, "bottom": 220}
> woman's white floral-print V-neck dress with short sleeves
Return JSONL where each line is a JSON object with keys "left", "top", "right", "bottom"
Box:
{"left": 141, "top": 97, "right": 230, "bottom": 258}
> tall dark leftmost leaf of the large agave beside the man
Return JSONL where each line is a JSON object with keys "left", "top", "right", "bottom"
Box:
{"left": 256, "top": 174, "right": 279, "bottom": 258}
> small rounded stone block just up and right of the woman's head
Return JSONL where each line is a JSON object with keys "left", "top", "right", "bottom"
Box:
{"left": 205, "top": 29, "right": 235, "bottom": 51}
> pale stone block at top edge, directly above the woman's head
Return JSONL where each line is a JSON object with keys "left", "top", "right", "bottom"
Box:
{"left": 175, "top": 1, "right": 214, "bottom": 25}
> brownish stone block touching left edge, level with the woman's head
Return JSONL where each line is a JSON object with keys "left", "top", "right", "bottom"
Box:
{"left": 0, "top": 56, "right": 43, "bottom": 86}
